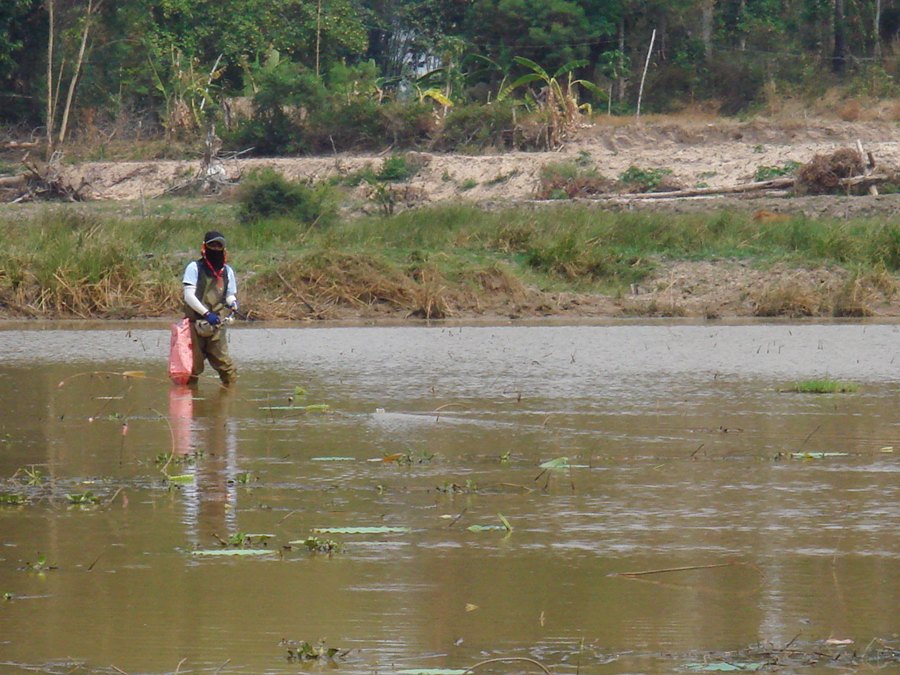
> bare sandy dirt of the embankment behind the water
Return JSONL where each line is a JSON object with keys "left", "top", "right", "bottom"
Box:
{"left": 5, "top": 119, "right": 900, "bottom": 319}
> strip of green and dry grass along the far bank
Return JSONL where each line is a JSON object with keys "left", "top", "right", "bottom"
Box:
{"left": 0, "top": 201, "right": 900, "bottom": 319}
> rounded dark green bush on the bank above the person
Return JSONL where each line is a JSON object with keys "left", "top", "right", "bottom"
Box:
{"left": 239, "top": 169, "right": 337, "bottom": 227}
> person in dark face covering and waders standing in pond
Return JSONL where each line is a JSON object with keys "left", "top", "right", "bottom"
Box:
{"left": 182, "top": 231, "right": 238, "bottom": 387}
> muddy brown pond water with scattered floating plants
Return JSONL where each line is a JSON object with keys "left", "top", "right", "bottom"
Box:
{"left": 0, "top": 323, "right": 900, "bottom": 673}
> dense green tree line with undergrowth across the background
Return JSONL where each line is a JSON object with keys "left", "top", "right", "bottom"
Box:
{"left": 0, "top": 0, "right": 900, "bottom": 153}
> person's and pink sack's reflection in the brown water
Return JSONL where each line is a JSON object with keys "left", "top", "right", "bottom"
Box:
{"left": 169, "top": 386, "right": 237, "bottom": 548}
